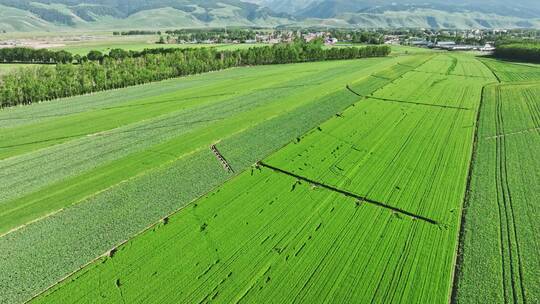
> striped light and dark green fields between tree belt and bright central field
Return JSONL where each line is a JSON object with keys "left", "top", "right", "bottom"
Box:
{"left": 0, "top": 56, "right": 429, "bottom": 303}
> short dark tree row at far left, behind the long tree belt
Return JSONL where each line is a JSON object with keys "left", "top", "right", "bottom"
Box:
{"left": 0, "top": 47, "right": 73, "bottom": 63}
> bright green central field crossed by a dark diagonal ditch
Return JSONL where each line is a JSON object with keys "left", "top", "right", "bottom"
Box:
{"left": 24, "top": 53, "right": 516, "bottom": 303}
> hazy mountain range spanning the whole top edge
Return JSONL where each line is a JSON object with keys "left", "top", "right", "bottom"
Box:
{"left": 0, "top": 0, "right": 540, "bottom": 31}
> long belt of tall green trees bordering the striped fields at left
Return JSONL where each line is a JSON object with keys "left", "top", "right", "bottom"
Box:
{"left": 0, "top": 43, "right": 390, "bottom": 107}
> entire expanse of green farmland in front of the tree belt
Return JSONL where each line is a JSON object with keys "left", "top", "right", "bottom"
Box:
{"left": 0, "top": 45, "right": 540, "bottom": 303}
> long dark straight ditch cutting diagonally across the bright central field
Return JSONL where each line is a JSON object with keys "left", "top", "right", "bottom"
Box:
{"left": 257, "top": 161, "right": 440, "bottom": 225}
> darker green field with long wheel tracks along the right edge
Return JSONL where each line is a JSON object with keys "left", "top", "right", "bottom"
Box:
{"left": 457, "top": 72, "right": 540, "bottom": 303}
